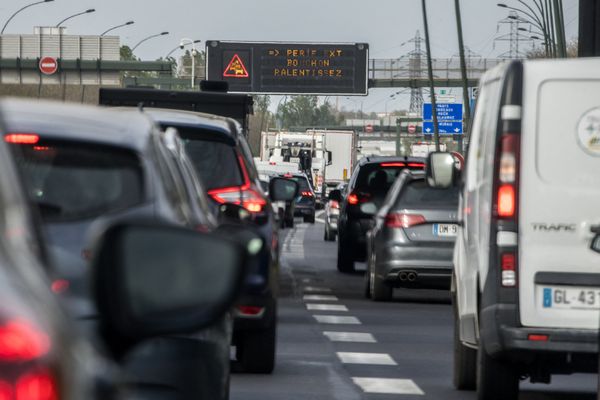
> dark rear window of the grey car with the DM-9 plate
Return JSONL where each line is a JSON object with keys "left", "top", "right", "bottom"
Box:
{"left": 396, "top": 179, "right": 458, "bottom": 207}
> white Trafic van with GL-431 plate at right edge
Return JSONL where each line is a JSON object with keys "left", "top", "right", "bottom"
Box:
{"left": 452, "top": 59, "right": 600, "bottom": 400}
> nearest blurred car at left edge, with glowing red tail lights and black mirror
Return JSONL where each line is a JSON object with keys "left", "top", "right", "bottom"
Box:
{"left": 0, "top": 102, "right": 247, "bottom": 400}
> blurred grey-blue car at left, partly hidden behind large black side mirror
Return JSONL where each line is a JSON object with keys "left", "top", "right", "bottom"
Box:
{"left": 0, "top": 100, "right": 232, "bottom": 399}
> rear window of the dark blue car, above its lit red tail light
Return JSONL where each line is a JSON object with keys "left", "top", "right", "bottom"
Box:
{"left": 180, "top": 135, "right": 244, "bottom": 190}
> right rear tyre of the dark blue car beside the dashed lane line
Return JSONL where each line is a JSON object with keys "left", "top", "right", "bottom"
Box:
{"left": 237, "top": 318, "right": 277, "bottom": 374}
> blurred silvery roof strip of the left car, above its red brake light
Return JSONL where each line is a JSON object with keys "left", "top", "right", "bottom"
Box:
{"left": 0, "top": 99, "right": 157, "bottom": 152}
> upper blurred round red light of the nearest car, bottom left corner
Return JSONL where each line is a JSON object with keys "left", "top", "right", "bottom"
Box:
{"left": 0, "top": 319, "right": 50, "bottom": 362}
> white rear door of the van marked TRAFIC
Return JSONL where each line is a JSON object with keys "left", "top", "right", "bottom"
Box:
{"left": 519, "top": 59, "right": 600, "bottom": 329}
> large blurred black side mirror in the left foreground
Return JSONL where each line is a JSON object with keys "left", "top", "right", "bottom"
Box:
{"left": 91, "top": 221, "right": 249, "bottom": 356}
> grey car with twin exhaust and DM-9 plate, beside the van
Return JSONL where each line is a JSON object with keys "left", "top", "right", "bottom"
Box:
{"left": 365, "top": 171, "right": 458, "bottom": 301}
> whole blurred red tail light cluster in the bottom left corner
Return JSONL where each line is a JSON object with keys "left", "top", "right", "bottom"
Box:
{"left": 0, "top": 319, "right": 58, "bottom": 400}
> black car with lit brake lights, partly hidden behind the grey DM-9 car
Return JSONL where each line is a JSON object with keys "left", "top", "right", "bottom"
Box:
{"left": 333, "top": 157, "right": 425, "bottom": 272}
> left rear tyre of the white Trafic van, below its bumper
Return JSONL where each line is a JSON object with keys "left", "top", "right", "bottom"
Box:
{"left": 477, "top": 338, "right": 519, "bottom": 400}
